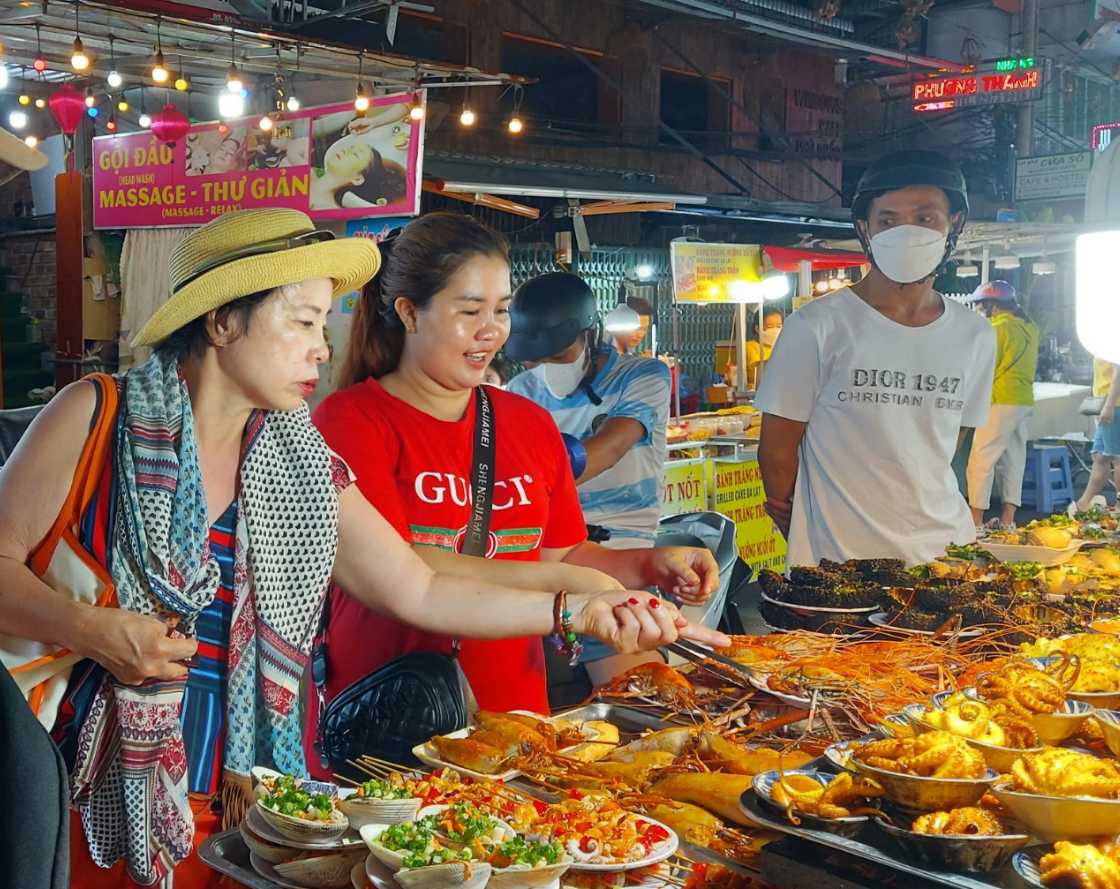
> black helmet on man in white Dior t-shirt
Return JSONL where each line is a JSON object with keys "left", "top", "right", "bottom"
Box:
{"left": 851, "top": 151, "right": 969, "bottom": 274}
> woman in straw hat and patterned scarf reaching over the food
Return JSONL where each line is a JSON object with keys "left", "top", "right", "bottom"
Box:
{"left": 0, "top": 209, "right": 720, "bottom": 889}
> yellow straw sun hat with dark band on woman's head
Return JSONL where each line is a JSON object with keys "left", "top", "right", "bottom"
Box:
{"left": 132, "top": 209, "right": 381, "bottom": 346}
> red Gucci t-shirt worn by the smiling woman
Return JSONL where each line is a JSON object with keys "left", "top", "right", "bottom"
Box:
{"left": 305, "top": 380, "right": 587, "bottom": 774}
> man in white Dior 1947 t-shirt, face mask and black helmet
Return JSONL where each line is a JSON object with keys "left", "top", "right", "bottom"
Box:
{"left": 755, "top": 151, "right": 996, "bottom": 567}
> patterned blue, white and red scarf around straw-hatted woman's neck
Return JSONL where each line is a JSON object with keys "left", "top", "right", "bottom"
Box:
{"left": 72, "top": 354, "right": 338, "bottom": 886}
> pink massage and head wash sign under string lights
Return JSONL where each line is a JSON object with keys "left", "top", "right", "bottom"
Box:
{"left": 93, "top": 95, "right": 423, "bottom": 228}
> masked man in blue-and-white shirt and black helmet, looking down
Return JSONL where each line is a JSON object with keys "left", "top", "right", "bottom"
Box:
{"left": 505, "top": 272, "right": 670, "bottom": 685}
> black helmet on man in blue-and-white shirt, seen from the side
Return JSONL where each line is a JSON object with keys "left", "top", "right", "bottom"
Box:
{"left": 505, "top": 272, "right": 600, "bottom": 362}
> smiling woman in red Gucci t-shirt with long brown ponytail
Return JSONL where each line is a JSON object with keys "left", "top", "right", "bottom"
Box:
{"left": 305, "top": 213, "right": 718, "bottom": 773}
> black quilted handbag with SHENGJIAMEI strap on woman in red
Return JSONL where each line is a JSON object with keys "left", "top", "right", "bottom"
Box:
{"left": 311, "top": 386, "right": 494, "bottom": 780}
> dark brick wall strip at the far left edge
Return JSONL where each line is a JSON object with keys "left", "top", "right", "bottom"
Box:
{"left": 0, "top": 174, "right": 57, "bottom": 348}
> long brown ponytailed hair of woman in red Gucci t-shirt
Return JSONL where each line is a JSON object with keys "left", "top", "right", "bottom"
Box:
{"left": 338, "top": 210, "right": 510, "bottom": 389}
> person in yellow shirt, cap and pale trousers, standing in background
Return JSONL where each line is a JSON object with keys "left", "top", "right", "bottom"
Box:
{"left": 965, "top": 281, "right": 1038, "bottom": 527}
